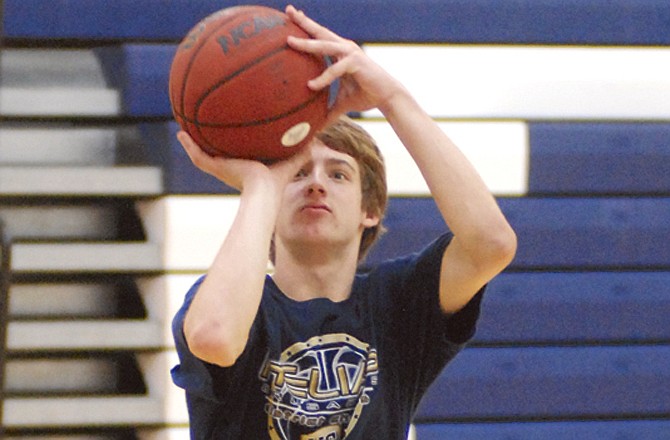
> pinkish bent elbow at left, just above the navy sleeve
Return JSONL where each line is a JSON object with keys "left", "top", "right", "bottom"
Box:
{"left": 184, "top": 324, "right": 247, "bottom": 367}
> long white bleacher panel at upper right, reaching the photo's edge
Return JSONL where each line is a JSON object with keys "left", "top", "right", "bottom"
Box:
{"left": 364, "top": 44, "right": 670, "bottom": 119}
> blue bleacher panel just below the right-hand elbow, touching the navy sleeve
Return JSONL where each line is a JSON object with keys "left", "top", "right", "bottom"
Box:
{"left": 475, "top": 272, "right": 670, "bottom": 344}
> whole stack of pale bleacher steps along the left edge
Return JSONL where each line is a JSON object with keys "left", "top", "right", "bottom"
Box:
{"left": 0, "top": 37, "right": 167, "bottom": 439}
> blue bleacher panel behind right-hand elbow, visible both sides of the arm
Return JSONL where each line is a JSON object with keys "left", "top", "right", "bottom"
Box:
{"left": 368, "top": 198, "right": 670, "bottom": 270}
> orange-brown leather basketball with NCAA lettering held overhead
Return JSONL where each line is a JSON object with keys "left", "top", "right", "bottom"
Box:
{"left": 169, "top": 6, "right": 329, "bottom": 162}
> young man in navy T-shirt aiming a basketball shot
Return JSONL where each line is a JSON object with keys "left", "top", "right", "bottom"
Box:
{"left": 173, "top": 6, "right": 516, "bottom": 440}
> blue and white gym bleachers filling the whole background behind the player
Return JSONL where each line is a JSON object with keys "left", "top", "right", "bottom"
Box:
{"left": 0, "top": 0, "right": 670, "bottom": 440}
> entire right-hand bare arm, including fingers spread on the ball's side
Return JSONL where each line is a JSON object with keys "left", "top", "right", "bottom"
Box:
{"left": 286, "top": 6, "right": 516, "bottom": 312}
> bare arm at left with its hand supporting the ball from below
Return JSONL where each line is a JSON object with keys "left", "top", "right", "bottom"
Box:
{"left": 178, "top": 132, "right": 304, "bottom": 366}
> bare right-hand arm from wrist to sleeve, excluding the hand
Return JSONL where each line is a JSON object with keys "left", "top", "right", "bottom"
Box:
{"left": 382, "top": 88, "right": 516, "bottom": 313}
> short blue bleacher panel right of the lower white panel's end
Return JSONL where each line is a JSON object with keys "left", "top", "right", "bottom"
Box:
{"left": 528, "top": 123, "right": 670, "bottom": 195}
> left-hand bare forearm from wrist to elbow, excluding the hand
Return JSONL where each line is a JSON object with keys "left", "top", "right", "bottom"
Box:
{"left": 184, "top": 180, "right": 280, "bottom": 366}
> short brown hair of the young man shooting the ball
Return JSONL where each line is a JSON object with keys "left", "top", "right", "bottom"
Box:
{"left": 316, "top": 116, "right": 388, "bottom": 261}
